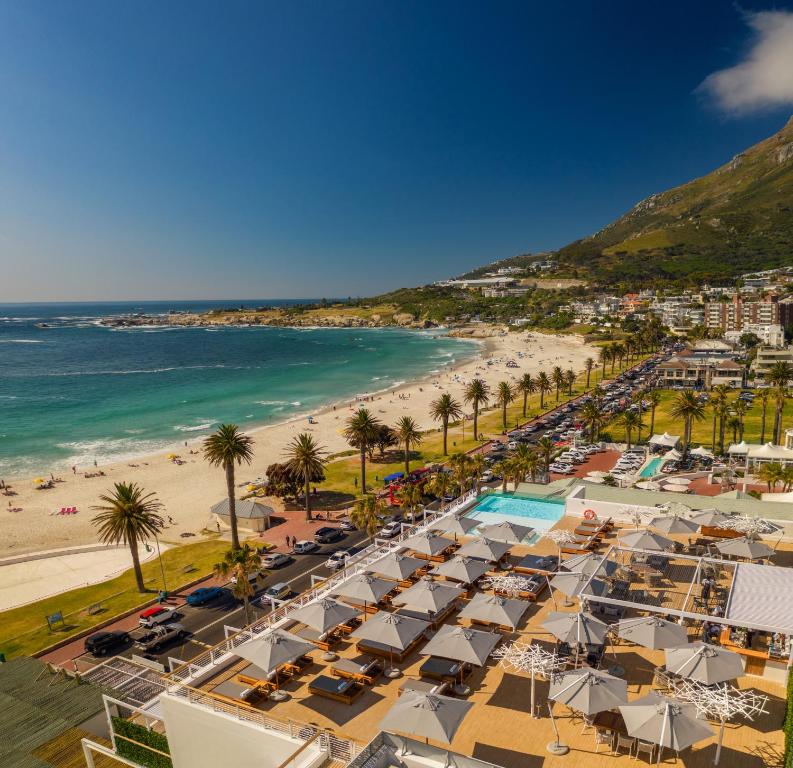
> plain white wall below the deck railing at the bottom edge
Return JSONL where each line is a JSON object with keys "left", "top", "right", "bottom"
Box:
{"left": 160, "top": 693, "right": 318, "bottom": 768}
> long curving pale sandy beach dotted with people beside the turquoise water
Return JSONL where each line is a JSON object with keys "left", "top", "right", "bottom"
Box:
{"left": 0, "top": 332, "right": 596, "bottom": 557}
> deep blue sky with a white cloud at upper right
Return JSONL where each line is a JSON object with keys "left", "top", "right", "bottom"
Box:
{"left": 0, "top": 0, "right": 793, "bottom": 301}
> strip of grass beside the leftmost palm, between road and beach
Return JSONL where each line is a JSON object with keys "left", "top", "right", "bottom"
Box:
{"left": 0, "top": 541, "right": 229, "bottom": 658}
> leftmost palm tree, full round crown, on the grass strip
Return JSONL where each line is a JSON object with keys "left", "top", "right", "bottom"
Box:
{"left": 91, "top": 483, "right": 164, "bottom": 592}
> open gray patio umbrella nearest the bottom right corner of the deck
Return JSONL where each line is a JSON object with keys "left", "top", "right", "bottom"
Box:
{"left": 620, "top": 693, "right": 713, "bottom": 763}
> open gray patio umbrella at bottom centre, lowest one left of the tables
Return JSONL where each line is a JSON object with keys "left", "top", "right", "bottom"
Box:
{"left": 380, "top": 691, "right": 473, "bottom": 744}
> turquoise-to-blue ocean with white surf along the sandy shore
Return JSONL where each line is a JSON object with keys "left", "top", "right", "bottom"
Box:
{"left": 0, "top": 300, "right": 478, "bottom": 479}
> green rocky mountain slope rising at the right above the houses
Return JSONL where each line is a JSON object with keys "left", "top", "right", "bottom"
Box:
{"left": 557, "top": 118, "right": 793, "bottom": 285}
